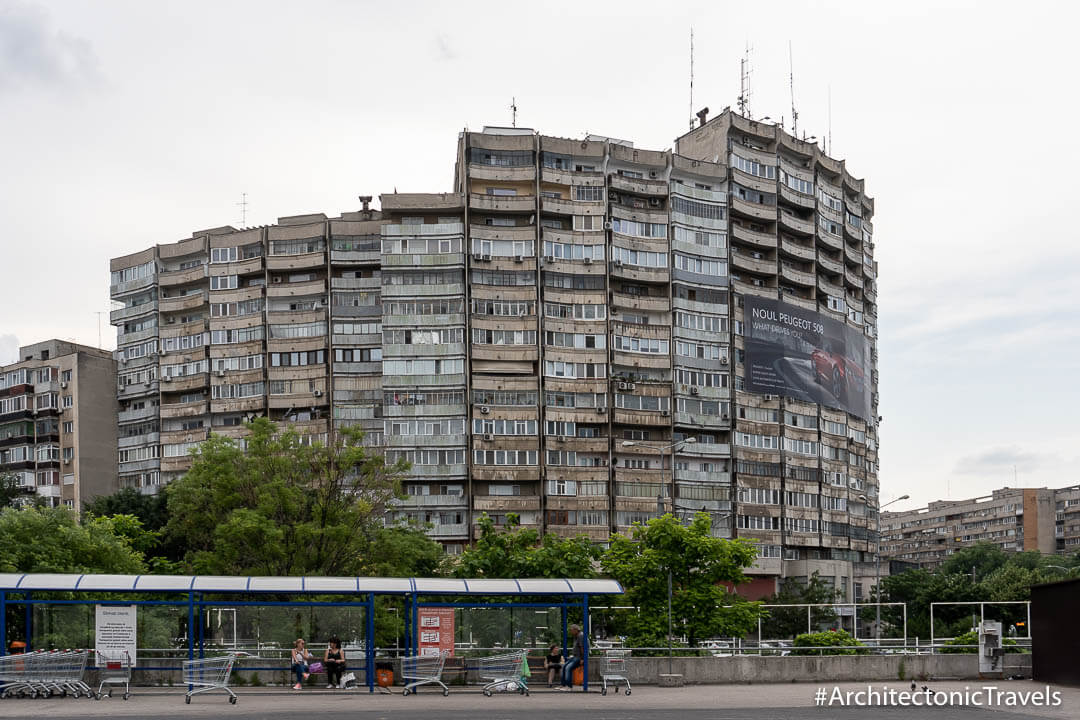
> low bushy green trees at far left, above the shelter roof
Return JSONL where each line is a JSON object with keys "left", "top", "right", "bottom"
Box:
{"left": 0, "top": 507, "right": 146, "bottom": 574}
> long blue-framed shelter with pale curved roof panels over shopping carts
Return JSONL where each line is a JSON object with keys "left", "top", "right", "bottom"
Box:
{"left": 0, "top": 573, "right": 622, "bottom": 692}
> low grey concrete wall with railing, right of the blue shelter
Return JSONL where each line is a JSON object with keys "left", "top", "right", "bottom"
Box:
{"left": 589, "top": 654, "right": 1031, "bottom": 684}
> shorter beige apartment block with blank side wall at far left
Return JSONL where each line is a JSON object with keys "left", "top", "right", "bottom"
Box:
{"left": 0, "top": 340, "right": 117, "bottom": 508}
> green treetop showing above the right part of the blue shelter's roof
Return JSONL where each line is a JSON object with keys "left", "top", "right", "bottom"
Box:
{"left": 454, "top": 513, "right": 600, "bottom": 578}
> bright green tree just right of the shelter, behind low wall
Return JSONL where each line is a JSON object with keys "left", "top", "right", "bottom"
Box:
{"left": 600, "top": 513, "right": 761, "bottom": 647}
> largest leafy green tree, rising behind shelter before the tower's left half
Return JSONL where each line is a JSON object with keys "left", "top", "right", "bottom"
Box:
{"left": 166, "top": 418, "right": 419, "bottom": 575}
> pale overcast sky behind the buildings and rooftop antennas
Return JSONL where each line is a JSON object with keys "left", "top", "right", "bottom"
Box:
{"left": 0, "top": 0, "right": 1080, "bottom": 510}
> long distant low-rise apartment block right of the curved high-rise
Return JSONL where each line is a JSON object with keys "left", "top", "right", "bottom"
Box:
{"left": 881, "top": 488, "right": 1058, "bottom": 568}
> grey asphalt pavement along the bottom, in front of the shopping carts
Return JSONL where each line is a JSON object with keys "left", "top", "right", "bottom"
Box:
{"left": 0, "top": 680, "right": 1080, "bottom": 720}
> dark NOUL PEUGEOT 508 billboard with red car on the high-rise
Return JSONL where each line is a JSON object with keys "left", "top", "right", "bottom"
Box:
{"left": 743, "top": 295, "right": 870, "bottom": 420}
